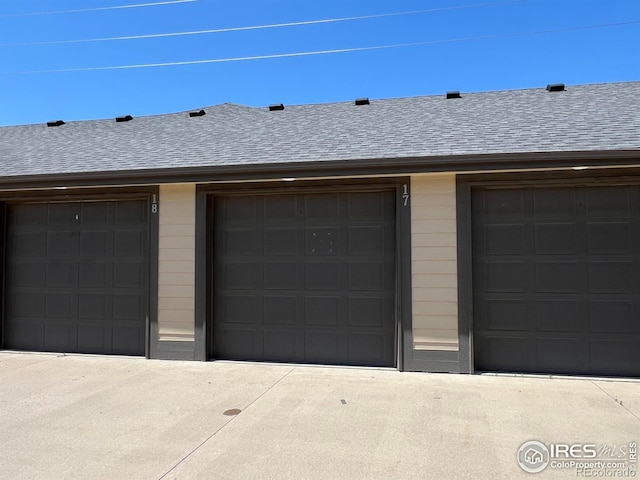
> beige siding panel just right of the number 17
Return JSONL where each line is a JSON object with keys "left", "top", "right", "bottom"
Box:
{"left": 411, "top": 174, "right": 458, "bottom": 350}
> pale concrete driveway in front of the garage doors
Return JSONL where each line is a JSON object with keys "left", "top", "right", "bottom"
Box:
{"left": 0, "top": 352, "right": 640, "bottom": 480}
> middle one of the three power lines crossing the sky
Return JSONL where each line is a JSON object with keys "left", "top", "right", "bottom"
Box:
{"left": 0, "top": 0, "right": 527, "bottom": 47}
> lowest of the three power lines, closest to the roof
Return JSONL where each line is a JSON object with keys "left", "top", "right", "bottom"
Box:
{"left": 0, "top": 20, "right": 640, "bottom": 75}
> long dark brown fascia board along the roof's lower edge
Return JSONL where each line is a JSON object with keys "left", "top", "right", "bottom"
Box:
{"left": 0, "top": 149, "right": 640, "bottom": 190}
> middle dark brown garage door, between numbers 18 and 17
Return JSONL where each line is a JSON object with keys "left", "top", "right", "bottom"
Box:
{"left": 213, "top": 191, "right": 396, "bottom": 366}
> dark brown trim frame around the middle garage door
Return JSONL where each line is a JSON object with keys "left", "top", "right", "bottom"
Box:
{"left": 195, "top": 178, "right": 411, "bottom": 370}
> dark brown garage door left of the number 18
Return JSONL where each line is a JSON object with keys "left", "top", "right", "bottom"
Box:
{"left": 4, "top": 200, "right": 148, "bottom": 355}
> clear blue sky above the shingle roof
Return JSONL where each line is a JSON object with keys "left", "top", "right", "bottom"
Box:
{"left": 0, "top": 0, "right": 640, "bottom": 125}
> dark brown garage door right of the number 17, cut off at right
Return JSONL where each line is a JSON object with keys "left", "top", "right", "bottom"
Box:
{"left": 472, "top": 186, "right": 640, "bottom": 376}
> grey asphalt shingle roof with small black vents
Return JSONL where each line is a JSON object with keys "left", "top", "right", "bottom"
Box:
{"left": 0, "top": 82, "right": 640, "bottom": 178}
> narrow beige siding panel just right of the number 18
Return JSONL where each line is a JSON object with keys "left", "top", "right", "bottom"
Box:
{"left": 158, "top": 184, "right": 196, "bottom": 341}
